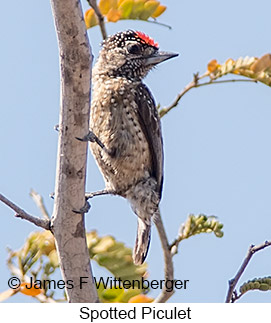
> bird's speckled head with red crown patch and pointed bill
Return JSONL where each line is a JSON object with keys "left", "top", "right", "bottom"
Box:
{"left": 96, "top": 30, "right": 178, "bottom": 80}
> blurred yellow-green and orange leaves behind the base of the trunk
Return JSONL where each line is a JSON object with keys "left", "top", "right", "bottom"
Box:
{"left": 0, "top": 231, "right": 147, "bottom": 302}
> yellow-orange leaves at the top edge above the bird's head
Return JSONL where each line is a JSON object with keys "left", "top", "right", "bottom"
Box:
{"left": 85, "top": 0, "right": 167, "bottom": 28}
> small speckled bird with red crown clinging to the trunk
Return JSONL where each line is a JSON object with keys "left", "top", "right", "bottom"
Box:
{"left": 88, "top": 30, "right": 178, "bottom": 265}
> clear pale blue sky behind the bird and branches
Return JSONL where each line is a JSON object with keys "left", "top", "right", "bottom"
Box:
{"left": 0, "top": 0, "right": 271, "bottom": 302}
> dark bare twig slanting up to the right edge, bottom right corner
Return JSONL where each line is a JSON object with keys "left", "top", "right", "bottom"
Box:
{"left": 225, "top": 241, "right": 271, "bottom": 303}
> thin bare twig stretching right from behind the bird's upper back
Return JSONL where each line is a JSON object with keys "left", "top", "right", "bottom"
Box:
{"left": 159, "top": 77, "right": 257, "bottom": 118}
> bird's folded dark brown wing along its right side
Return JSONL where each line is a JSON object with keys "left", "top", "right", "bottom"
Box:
{"left": 135, "top": 83, "right": 164, "bottom": 197}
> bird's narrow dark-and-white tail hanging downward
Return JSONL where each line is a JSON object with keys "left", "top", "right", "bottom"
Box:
{"left": 133, "top": 217, "right": 151, "bottom": 265}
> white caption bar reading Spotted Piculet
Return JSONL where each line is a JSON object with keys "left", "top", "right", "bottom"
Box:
{"left": 0, "top": 303, "right": 271, "bottom": 323}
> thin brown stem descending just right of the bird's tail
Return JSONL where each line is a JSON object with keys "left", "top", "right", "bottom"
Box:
{"left": 154, "top": 211, "right": 174, "bottom": 303}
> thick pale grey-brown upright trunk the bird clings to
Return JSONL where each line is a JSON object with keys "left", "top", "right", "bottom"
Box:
{"left": 51, "top": 0, "right": 98, "bottom": 302}
